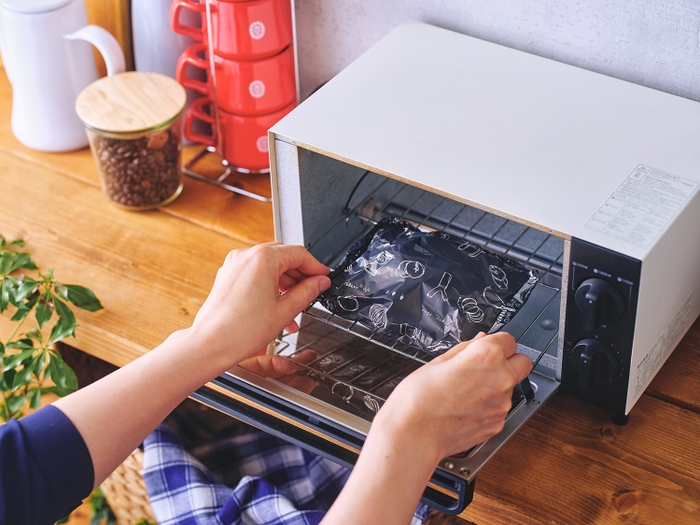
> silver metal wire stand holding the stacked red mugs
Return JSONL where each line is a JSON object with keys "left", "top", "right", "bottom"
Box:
{"left": 182, "top": 0, "right": 272, "bottom": 202}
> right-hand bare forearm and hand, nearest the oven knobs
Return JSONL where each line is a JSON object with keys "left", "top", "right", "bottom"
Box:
{"left": 322, "top": 333, "right": 532, "bottom": 525}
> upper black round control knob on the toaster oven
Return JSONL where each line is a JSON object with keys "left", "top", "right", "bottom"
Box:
{"left": 575, "top": 277, "right": 625, "bottom": 332}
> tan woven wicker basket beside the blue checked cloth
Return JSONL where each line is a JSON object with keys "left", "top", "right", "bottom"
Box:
{"left": 100, "top": 449, "right": 156, "bottom": 525}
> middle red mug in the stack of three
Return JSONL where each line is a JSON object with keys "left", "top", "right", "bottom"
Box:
{"left": 175, "top": 44, "right": 297, "bottom": 115}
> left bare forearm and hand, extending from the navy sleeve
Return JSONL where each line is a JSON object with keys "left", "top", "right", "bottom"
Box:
{"left": 54, "top": 244, "right": 330, "bottom": 492}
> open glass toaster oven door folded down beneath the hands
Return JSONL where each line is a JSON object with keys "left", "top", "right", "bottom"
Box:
{"left": 193, "top": 307, "right": 558, "bottom": 514}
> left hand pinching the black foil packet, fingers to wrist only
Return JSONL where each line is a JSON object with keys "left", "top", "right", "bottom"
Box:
{"left": 191, "top": 243, "right": 330, "bottom": 371}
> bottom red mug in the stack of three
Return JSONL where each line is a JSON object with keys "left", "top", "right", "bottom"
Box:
{"left": 184, "top": 98, "right": 296, "bottom": 172}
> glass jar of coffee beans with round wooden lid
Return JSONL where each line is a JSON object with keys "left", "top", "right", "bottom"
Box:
{"left": 75, "top": 72, "right": 187, "bottom": 210}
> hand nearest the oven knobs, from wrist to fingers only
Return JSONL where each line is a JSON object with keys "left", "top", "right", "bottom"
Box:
{"left": 372, "top": 333, "right": 532, "bottom": 467}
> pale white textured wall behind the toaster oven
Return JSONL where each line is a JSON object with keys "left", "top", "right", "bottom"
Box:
{"left": 295, "top": 0, "right": 700, "bottom": 101}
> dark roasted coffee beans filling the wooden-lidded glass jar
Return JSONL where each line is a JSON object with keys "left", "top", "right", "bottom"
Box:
{"left": 90, "top": 129, "right": 182, "bottom": 208}
